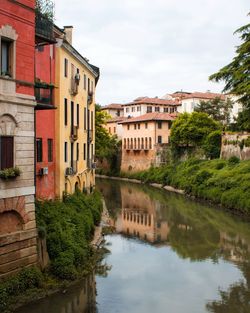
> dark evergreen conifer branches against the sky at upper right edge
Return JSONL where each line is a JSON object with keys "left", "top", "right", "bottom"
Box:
{"left": 209, "top": 13, "right": 250, "bottom": 108}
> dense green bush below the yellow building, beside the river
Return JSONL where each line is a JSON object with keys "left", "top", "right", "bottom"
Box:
{"left": 36, "top": 192, "right": 102, "bottom": 280}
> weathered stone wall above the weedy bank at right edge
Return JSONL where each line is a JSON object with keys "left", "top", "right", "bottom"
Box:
{"left": 221, "top": 133, "right": 250, "bottom": 160}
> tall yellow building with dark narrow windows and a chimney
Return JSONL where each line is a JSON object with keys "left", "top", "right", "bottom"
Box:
{"left": 55, "top": 26, "right": 99, "bottom": 198}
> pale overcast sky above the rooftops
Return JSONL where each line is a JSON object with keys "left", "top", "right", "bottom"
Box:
{"left": 55, "top": 0, "right": 250, "bottom": 105}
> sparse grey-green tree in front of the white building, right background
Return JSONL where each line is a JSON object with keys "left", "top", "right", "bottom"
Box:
{"left": 194, "top": 97, "right": 233, "bottom": 125}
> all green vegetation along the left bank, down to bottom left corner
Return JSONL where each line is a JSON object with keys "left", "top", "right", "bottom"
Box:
{"left": 0, "top": 192, "right": 102, "bottom": 312}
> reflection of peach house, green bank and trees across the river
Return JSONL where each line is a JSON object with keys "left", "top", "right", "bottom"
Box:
{"left": 98, "top": 180, "right": 250, "bottom": 313}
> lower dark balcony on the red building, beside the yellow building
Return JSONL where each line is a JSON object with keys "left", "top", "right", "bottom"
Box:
{"left": 35, "top": 83, "right": 55, "bottom": 110}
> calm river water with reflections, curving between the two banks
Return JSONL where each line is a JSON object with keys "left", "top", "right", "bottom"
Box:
{"left": 17, "top": 179, "right": 250, "bottom": 313}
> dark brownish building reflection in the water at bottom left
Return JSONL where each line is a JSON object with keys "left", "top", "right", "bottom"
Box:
{"left": 15, "top": 274, "right": 96, "bottom": 313}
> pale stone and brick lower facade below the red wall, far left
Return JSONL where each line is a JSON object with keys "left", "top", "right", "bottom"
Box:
{"left": 0, "top": 90, "right": 37, "bottom": 279}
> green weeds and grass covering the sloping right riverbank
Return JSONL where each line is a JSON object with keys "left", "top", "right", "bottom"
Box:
{"left": 127, "top": 157, "right": 250, "bottom": 215}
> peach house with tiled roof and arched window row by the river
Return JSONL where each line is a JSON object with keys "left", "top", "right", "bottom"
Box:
{"left": 119, "top": 113, "right": 176, "bottom": 172}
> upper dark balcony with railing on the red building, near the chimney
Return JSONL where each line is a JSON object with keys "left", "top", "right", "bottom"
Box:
{"left": 36, "top": 11, "right": 56, "bottom": 45}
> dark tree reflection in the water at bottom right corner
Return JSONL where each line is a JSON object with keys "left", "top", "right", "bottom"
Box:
{"left": 206, "top": 263, "right": 250, "bottom": 313}
